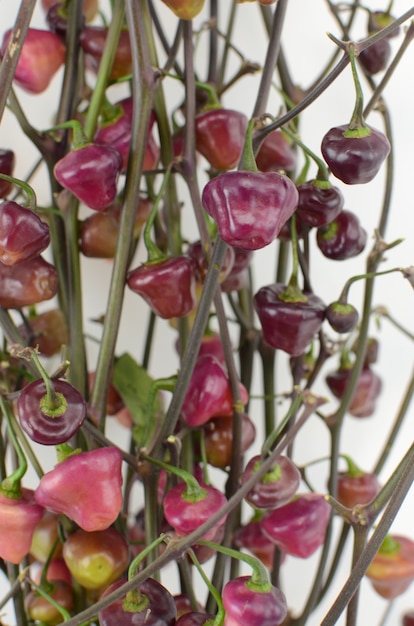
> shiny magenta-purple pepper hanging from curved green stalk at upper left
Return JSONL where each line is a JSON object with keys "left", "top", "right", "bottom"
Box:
{"left": 53, "top": 143, "right": 122, "bottom": 211}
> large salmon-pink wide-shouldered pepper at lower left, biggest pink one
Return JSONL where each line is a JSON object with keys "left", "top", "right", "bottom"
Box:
{"left": 35, "top": 446, "right": 122, "bottom": 531}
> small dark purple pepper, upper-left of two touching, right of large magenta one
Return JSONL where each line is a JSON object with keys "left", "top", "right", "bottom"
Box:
{"left": 296, "top": 180, "right": 344, "bottom": 228}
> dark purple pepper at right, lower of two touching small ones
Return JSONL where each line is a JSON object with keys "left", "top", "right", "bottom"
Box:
{"left": 316, "top": 209, "right": 367, "bottom": 261}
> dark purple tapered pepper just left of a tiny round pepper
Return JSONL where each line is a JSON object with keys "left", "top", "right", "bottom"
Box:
{"left": 254, "top": 283, "right": 326, "bottom": 356}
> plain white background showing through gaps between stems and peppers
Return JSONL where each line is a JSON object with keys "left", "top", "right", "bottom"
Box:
{"left": 0, "top": 0, "right": 414, "bottom": 626}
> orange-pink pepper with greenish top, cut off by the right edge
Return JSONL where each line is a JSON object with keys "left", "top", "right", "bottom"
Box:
{"left": 365, "top": 535, "right": 414, "bottom": 600}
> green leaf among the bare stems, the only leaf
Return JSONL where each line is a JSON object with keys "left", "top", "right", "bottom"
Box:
{"left": 112, "top": 352, "right": 164, "bottom": 447}
